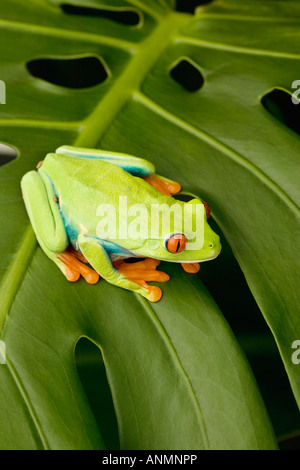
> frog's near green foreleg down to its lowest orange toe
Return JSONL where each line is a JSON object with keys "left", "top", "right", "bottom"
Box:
{"left": 78, "top": 235, "right": 162, "bottom": 300}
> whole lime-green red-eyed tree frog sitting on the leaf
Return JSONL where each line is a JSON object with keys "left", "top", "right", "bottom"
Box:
{"left": 21, "top": 145, "right": 221, "bottom": 302}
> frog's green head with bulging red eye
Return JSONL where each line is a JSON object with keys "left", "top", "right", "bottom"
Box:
{"left": 135, "top": 199, "right": 221, "bottom": 263}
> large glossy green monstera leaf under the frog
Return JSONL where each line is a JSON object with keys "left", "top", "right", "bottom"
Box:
{"left": 0, "top": 0, "right": 300, "bottom": 449}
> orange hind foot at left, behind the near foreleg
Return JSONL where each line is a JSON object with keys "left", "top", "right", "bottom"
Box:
{"left": 56, "top": 247, "right": 100, "bottom": 284}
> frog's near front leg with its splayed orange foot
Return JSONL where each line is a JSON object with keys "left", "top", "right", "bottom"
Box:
{"left": 78, "top": 234, "right": 169, "bottom": 302}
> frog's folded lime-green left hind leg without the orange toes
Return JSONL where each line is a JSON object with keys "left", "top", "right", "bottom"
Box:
{"left": 21, "top": 170, "right": 69, "bottom": 275}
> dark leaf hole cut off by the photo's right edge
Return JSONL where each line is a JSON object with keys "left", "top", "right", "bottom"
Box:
{"left": 261, "top": 88, "right": 300, "bottom": 135}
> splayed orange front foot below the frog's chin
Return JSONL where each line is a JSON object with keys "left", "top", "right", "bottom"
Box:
{"left": 114, "top": 258, "right": 170, "bottom": 302}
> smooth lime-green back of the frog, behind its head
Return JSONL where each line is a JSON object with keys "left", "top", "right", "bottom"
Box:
{"left": 40, "top": 154, "right": 181, "bottom": 249}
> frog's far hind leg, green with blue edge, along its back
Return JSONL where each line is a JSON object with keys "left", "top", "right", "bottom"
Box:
{"left": 56, "top": 145, "right": 155, "bottom": 178}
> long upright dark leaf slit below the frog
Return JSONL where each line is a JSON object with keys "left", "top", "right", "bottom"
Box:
{"left": 75, "top": 337, "right": 120, "bottom": 450}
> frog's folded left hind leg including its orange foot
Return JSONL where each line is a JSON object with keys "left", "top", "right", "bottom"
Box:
{"left": 21, "top": 171, "right": 99, "bottom": 284}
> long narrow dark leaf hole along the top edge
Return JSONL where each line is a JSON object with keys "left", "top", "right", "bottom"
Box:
{"left": 61, "top": 3, "right": 142, "bottom": 26}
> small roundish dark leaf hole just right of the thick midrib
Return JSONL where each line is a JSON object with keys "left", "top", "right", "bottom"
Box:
{"left": 170, "top": 58, "right": 204, "bottom": 92}
